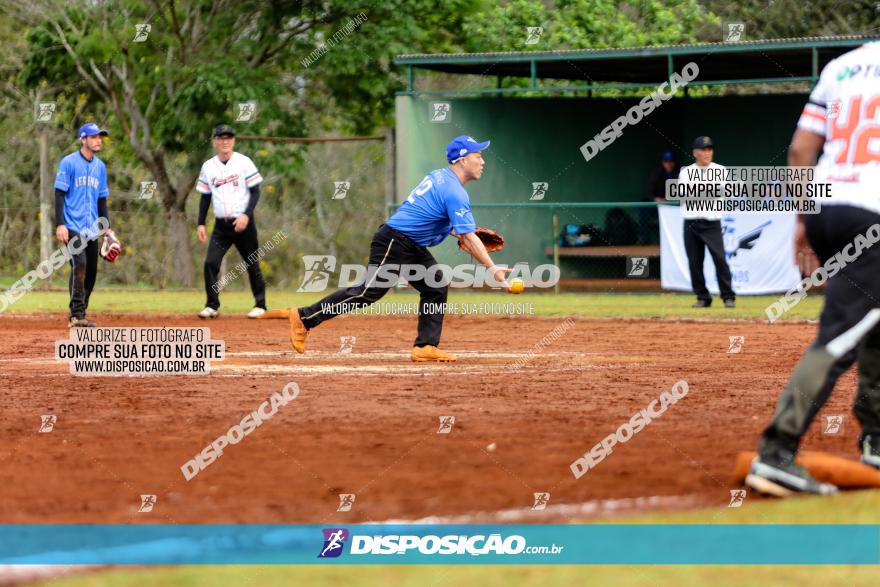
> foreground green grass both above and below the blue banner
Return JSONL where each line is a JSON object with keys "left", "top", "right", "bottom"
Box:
{"left": 32, "top": 491, "right": 880, "bottom": 587}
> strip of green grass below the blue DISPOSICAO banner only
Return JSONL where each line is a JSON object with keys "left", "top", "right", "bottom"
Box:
{"left": 31, "top": 565, "right": 877, "bottom": 587}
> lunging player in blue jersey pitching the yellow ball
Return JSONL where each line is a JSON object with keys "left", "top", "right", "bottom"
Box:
{"left": 289, "top": 136, "right": 510, "bottom": 362}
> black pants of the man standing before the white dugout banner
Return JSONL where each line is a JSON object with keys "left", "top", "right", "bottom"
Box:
{"left": 684, "top": 220, "right": 736, "bottom": 304}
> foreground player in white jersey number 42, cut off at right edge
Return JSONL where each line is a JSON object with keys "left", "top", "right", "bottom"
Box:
{"left": 746, "top": 43, "right": 880, "bottom": 495}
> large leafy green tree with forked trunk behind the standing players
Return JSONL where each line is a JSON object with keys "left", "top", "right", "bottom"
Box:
{"left": 11, "top": 0, "right": 479, "bottom": 286}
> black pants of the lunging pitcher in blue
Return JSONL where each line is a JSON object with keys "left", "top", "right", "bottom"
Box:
{"left": 299, "top": 224, "right": 449, "bottom": 346}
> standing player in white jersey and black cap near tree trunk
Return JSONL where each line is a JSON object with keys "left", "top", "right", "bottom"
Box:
{"left": 196, "top": 124, "right": 266, "bottom": 318}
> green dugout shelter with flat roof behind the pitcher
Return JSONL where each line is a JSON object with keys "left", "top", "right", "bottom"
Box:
{"left": 389, "top": 36, "right": 877, "bottom": 290}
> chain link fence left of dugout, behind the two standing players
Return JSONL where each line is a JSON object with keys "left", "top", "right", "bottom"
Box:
{"left": 0, "top": 141, "right": 388, "bottom": 290}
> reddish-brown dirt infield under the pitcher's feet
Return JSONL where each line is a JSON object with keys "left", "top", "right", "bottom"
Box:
{"left": 0, "top": 314, "right": 858, "bottom": 524}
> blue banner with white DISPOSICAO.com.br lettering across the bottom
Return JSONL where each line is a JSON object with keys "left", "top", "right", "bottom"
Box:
{"left": 0, "top": 524, "right": 880, "bottom": 565}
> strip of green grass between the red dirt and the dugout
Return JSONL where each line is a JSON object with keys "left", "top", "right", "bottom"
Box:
{"left": 6, "top": 288, "right": 822, "bottom": 320}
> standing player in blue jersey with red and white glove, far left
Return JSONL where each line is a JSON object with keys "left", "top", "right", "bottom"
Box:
{"left": 55, "top": 122, "right": 110, "bottom": 327}
